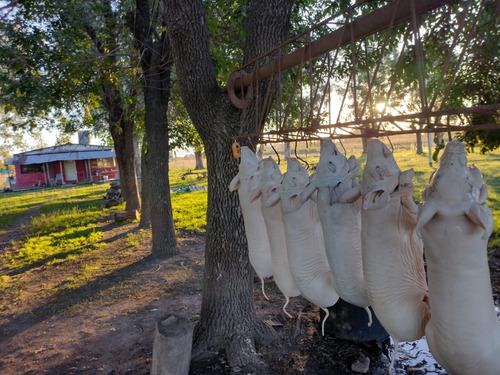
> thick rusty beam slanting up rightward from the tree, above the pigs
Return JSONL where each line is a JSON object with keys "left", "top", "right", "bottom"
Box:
{"left": 228, "top": 0, "right": 457, "bottom": 96}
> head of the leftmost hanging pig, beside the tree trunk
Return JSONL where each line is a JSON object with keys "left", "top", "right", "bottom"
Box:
{"left": 229, "top": 146, "right": 262, "bottom": 201}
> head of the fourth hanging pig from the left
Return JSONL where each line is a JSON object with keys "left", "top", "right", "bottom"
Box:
{"left": 301, "top": 139, "right": 359, "bottom": 205}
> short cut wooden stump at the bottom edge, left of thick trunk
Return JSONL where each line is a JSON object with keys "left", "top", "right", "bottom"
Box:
{"left": 151, "top": 315, "right": 194, "bottom": 375}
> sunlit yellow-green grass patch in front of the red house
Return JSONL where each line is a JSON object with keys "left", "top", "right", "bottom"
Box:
{"left": 2, "top": 184, "right": 109, "bottom": 269}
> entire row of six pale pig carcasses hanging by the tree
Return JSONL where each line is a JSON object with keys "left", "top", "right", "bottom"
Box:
{"left": 230, "top": 139, "right": 500, "bottom": 375}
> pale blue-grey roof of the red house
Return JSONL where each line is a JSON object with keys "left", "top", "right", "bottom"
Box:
{"left": 6, "top": 143, "right": 116, "bottom": 165}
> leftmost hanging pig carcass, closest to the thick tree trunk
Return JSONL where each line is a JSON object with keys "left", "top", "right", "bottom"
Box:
{"left": 229, "top": 146, "right": 273, "bottom": 298}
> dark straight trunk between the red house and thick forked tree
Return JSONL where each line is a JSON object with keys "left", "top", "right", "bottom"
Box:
{"left": 128, "top": 0, "right": 178, "bottom": 257}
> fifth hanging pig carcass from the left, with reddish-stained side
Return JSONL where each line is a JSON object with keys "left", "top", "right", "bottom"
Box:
{"left": 361, "top": 139, "right": 430, "bottom": 374}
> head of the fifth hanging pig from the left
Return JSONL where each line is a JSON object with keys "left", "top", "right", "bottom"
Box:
{"left": 362, "top": 139, "right": 401, "bottom": 210}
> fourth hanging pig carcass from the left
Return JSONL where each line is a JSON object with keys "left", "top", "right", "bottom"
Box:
{"left": 301, "top": 139, "right": 371, "bottom": 326}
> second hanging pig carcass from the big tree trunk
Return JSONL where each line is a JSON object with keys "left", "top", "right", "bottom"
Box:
{"left": 252, "top": 157, "right": 300, "bottom": 318}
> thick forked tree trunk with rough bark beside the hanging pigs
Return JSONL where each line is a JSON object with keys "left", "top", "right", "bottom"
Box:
{"left": 164, "top": 0, "right": 293, "bottom": 366}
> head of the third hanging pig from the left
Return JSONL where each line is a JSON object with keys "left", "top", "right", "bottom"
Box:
{"left": 281, "top": 158, "right": 309, "bottom": 212}
